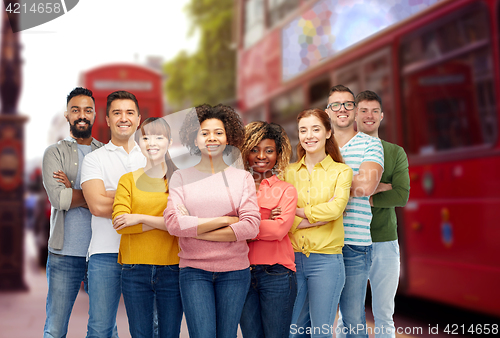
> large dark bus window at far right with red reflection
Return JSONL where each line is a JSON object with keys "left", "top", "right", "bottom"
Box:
{"left": 400, "top": 6, "right": 497, "bottom": 155}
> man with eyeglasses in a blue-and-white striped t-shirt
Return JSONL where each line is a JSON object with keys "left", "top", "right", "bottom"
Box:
{"left": 326, "top": 85, "right": 384, "bottom": 338}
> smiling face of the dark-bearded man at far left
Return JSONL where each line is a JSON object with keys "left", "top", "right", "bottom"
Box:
{"left": 64, "top": 95, "right": 95, "bottom": 139}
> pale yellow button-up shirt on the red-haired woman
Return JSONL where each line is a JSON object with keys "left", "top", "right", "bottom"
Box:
{"left": 285, "top": 155, "right": 352, "bottom": 256}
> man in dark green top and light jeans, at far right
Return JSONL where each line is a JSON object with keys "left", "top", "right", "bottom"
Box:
{"left": 356, "top": 90, "right": 410, "bottom": 338}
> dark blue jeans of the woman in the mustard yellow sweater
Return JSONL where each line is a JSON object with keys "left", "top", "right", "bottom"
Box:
{"left": 122, "top": 264, "right": 182, "bottom": 338}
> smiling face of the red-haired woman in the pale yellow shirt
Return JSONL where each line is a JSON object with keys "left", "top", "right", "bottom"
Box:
{"left": 299, "top": 115, "right": 332, "bottom": 154}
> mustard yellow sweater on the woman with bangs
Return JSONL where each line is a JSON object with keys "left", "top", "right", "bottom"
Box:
{"left": 113, "top": 169, "right": 179, "bottom": 265}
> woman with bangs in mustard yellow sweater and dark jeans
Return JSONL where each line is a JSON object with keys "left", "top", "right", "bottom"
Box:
{"left": 113, "top": 118, "right": 182, "bottom": 337}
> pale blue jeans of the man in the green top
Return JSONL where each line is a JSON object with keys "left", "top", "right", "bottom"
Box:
{"left": 369, "top": 240, "right": 399, "bottom": 338}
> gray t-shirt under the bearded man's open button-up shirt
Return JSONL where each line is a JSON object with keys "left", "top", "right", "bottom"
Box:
{"left": 49, "top": 144, "right": 92, "bottom": 257}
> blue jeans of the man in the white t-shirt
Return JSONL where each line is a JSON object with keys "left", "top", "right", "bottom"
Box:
{"left": 87, "top": 253, "right": 122, "bottom": 338}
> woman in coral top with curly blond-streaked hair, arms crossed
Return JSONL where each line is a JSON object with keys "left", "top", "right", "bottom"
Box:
{"left": 240, "top": 122, "right": 297, "bottom": 338}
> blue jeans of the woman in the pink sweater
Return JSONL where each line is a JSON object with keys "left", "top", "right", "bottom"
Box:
{"left": 179, "top": 267, "right": 250, "bottom": 338}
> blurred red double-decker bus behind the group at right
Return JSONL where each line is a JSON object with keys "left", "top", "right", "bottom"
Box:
{"left": 237, "top": 0, "right": 500, "bottom": 316}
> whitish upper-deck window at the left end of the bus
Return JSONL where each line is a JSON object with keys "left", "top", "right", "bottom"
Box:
{"left": 243, "top": 0, "right": 266, "bottom": 48}
